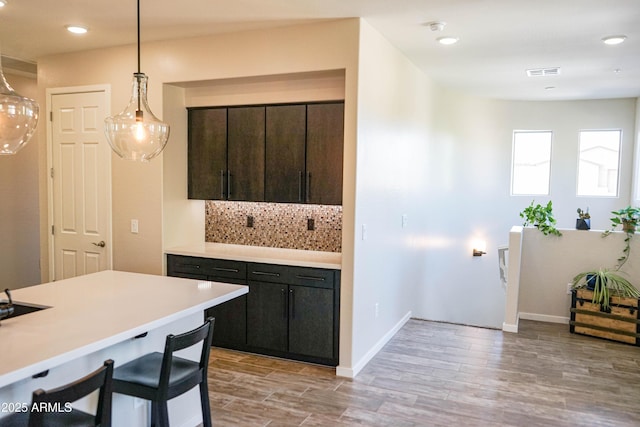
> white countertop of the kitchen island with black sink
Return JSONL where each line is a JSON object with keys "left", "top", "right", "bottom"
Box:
{"left": 0, "top": 270, "right": 248, "bottom": 387}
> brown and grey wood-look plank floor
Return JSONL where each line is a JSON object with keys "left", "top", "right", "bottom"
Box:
{"left": 209, "top": 320, "right": 640, "bottom": 427}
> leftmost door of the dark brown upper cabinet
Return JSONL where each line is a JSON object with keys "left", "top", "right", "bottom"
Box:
{"left": 188, "top": 108, "right": 227, "bottom": 200}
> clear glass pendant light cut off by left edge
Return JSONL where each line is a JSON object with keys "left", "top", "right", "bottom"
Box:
{"left": 0, "top": 56, "right": 39, "bottom": 154}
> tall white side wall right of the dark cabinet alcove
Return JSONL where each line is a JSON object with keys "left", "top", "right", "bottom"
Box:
{"left": 345, "top": 21, "right": 433, "bottom": 372}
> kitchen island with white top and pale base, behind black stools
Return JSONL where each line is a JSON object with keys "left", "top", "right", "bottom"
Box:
{"left": 0, "top": 270, "right": 248, "bottom": 426}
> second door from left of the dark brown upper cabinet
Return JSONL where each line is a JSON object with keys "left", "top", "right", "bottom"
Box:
{"left": 227, "top": 106, "right": 265, "bottom": 202}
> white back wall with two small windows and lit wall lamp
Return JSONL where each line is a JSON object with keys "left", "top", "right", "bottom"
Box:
{"left": 414, "top": 90, "right": 635, "bottom": 328}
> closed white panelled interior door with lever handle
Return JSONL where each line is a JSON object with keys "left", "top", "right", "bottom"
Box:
{"left": 50, "top": 90, "right": 111, "bottom": 280}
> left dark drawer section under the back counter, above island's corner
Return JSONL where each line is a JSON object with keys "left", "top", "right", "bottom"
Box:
{"left": 167, "top": 255, "right": 247, "bottom": 282}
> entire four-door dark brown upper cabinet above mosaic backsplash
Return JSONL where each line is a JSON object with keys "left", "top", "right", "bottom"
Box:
{"left": 188, "top": 102, "right": 344, "bottom": 205}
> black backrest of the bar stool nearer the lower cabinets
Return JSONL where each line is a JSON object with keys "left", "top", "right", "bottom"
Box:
{"left": 158, "top": 317, "right": 215, "bottom": 395}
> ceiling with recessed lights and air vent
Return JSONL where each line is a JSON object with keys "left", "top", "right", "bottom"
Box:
{"left": 0, "top": 0, "right": 640, "bottom": 100}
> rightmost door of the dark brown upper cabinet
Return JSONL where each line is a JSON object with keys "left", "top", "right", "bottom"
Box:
{"left": 305, "top": 102, "right": 344, "bottom": 205}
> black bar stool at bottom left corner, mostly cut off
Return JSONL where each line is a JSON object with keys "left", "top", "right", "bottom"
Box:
{"left": 0, "top": 359, "right": 113, "bottom": 427}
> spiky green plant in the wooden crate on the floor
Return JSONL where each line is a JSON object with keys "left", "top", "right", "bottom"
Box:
{"left": 572, "top": 268, "right": 640, "bottom": 312}
